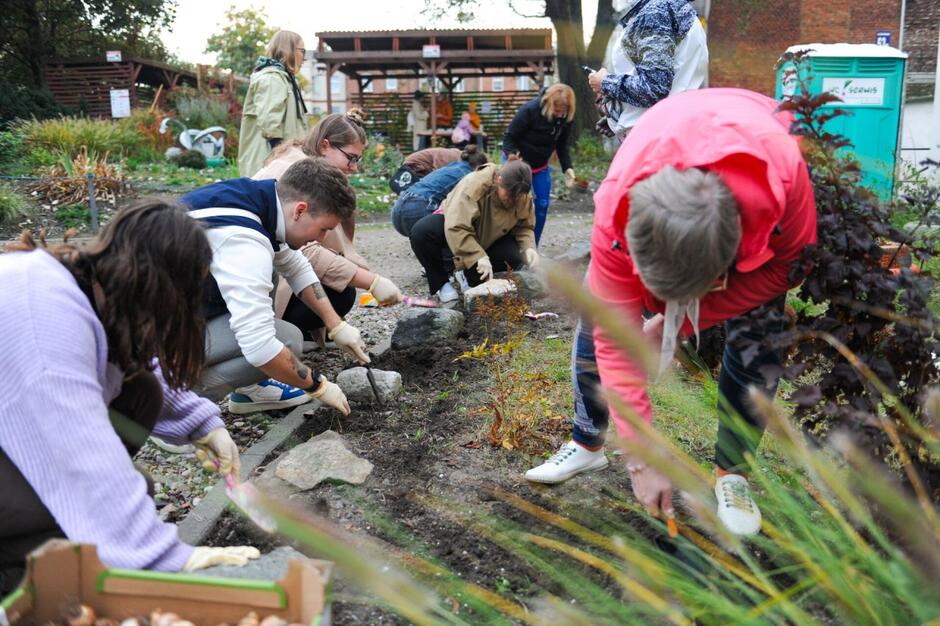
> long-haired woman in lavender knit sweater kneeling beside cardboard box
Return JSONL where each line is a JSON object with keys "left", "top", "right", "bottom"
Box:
{"left": 0, "top": 201, "right": 258, "bottom": 596}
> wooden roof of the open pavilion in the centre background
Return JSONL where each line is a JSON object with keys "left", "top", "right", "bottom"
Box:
{"left": 314, "top": 28, "right": 555, "bottom": 78}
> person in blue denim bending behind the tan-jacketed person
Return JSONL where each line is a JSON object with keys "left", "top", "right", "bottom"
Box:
{"left": 392, "top": 146, "right": 488, "bottom": 237}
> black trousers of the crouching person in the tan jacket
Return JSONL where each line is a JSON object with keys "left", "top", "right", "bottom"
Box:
{"left": 411, "top": 214, "right": 523, "bottom": 296}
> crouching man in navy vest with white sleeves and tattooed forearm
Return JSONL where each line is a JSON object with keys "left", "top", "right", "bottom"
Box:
{"left": 180, "top": 159, "right": 358, "bottom": 415}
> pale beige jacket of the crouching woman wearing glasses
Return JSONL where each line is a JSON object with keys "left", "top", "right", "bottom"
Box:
{"left": 252, "top": 147, "right": 369, "bottom": 318}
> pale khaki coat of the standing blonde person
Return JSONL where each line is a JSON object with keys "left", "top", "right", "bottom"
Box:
{"left": 238, "top": 67, "right": 307, "bottom": 176}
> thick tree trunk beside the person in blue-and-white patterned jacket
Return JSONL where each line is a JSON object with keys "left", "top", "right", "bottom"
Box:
{"left": 545, "top": 0, "right": 610, "bottom": 141}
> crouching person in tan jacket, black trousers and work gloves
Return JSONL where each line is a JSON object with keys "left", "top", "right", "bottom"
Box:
{"left": 411, "top": 159, "right": 539, "bottom": 304}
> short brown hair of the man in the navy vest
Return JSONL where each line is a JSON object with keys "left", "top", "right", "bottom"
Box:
{"left": 277, "top": 158, "right": 356, "bottom": 220}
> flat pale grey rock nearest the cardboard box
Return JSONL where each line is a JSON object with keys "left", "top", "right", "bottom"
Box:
{"left": 274, "top": 430, "right": 372, "bottom": 490}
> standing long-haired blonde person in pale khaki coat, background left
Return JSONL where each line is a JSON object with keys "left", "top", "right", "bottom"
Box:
{"left": 238, "top": 30, "right": 307, "bottom": 176}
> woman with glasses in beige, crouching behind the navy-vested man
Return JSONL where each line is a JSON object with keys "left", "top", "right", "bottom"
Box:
{"left": 253, "top": 109, "right": 401, "bottom": 335}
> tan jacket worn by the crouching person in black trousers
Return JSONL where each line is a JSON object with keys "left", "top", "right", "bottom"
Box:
{"left": 441, "top": 163, "right": 535, "bottom": 270}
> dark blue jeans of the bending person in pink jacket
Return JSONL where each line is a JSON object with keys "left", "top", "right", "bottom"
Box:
{"left": 571, "top": 297, "right": 784, "bottom": 471}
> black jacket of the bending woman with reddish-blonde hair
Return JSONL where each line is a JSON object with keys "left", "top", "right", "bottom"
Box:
{"left": 503, "top": 94, "right": 571, "bottom": 171}
